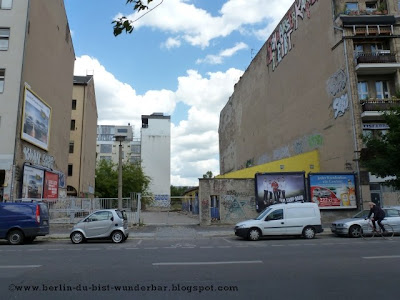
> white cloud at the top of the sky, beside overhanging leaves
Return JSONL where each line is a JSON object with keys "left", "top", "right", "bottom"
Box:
{"left": 116, "top": 0, "right": 293, "bottom": 48}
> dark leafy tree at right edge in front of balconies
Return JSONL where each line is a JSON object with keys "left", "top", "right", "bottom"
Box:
{"left": 360, "top": 107, "right": 400, "bottom": 189}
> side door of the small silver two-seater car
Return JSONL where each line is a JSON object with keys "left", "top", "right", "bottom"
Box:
{"left": 85, "top": 211, "right": 114, "bottom": 238}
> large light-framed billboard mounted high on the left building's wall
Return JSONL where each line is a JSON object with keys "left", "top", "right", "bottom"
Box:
{"left": 21, "top": 87, "right": 51, "bottom": 150}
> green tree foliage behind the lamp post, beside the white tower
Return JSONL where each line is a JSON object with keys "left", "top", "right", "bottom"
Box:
{"left": 95, "top": 160, "right": 150, "bottom": 198}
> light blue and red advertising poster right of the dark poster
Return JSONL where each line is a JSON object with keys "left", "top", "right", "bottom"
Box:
{"left": 308, "top": 173, "right": 357, "bottom": 209}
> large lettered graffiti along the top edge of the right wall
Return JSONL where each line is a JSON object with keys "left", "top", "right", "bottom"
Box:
{"left": 267, "top": 0, "right": 318, "bottom": 71}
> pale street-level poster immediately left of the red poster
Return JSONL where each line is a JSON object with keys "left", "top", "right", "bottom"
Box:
{"left": 22, "top": 165, "right": 44, "bottom": 199}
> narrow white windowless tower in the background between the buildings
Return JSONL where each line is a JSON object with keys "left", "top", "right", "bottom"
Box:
{"left": 141, "top": 113, "right": 171, "bottom": 207}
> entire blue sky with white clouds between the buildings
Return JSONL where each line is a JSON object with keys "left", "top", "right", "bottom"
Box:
{"left": 65, "top": 0, "right": 294, "bottom": 186}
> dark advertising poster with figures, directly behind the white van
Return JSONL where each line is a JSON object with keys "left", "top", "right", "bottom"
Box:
{"left": 255, "top": 172, "right": 306, "bottom": 212}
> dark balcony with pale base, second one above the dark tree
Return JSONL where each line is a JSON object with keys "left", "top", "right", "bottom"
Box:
{"left": 355, "top": 50, "right": 400, "bottom": 75}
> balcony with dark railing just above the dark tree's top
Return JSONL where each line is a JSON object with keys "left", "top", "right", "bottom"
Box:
{"left": 360, "top": 97, "right": 400, "bottom": 121}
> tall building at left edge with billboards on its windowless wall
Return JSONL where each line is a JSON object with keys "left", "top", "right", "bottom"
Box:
{"left": 0, "top": 0, "right": 75, "bottom": 200}
